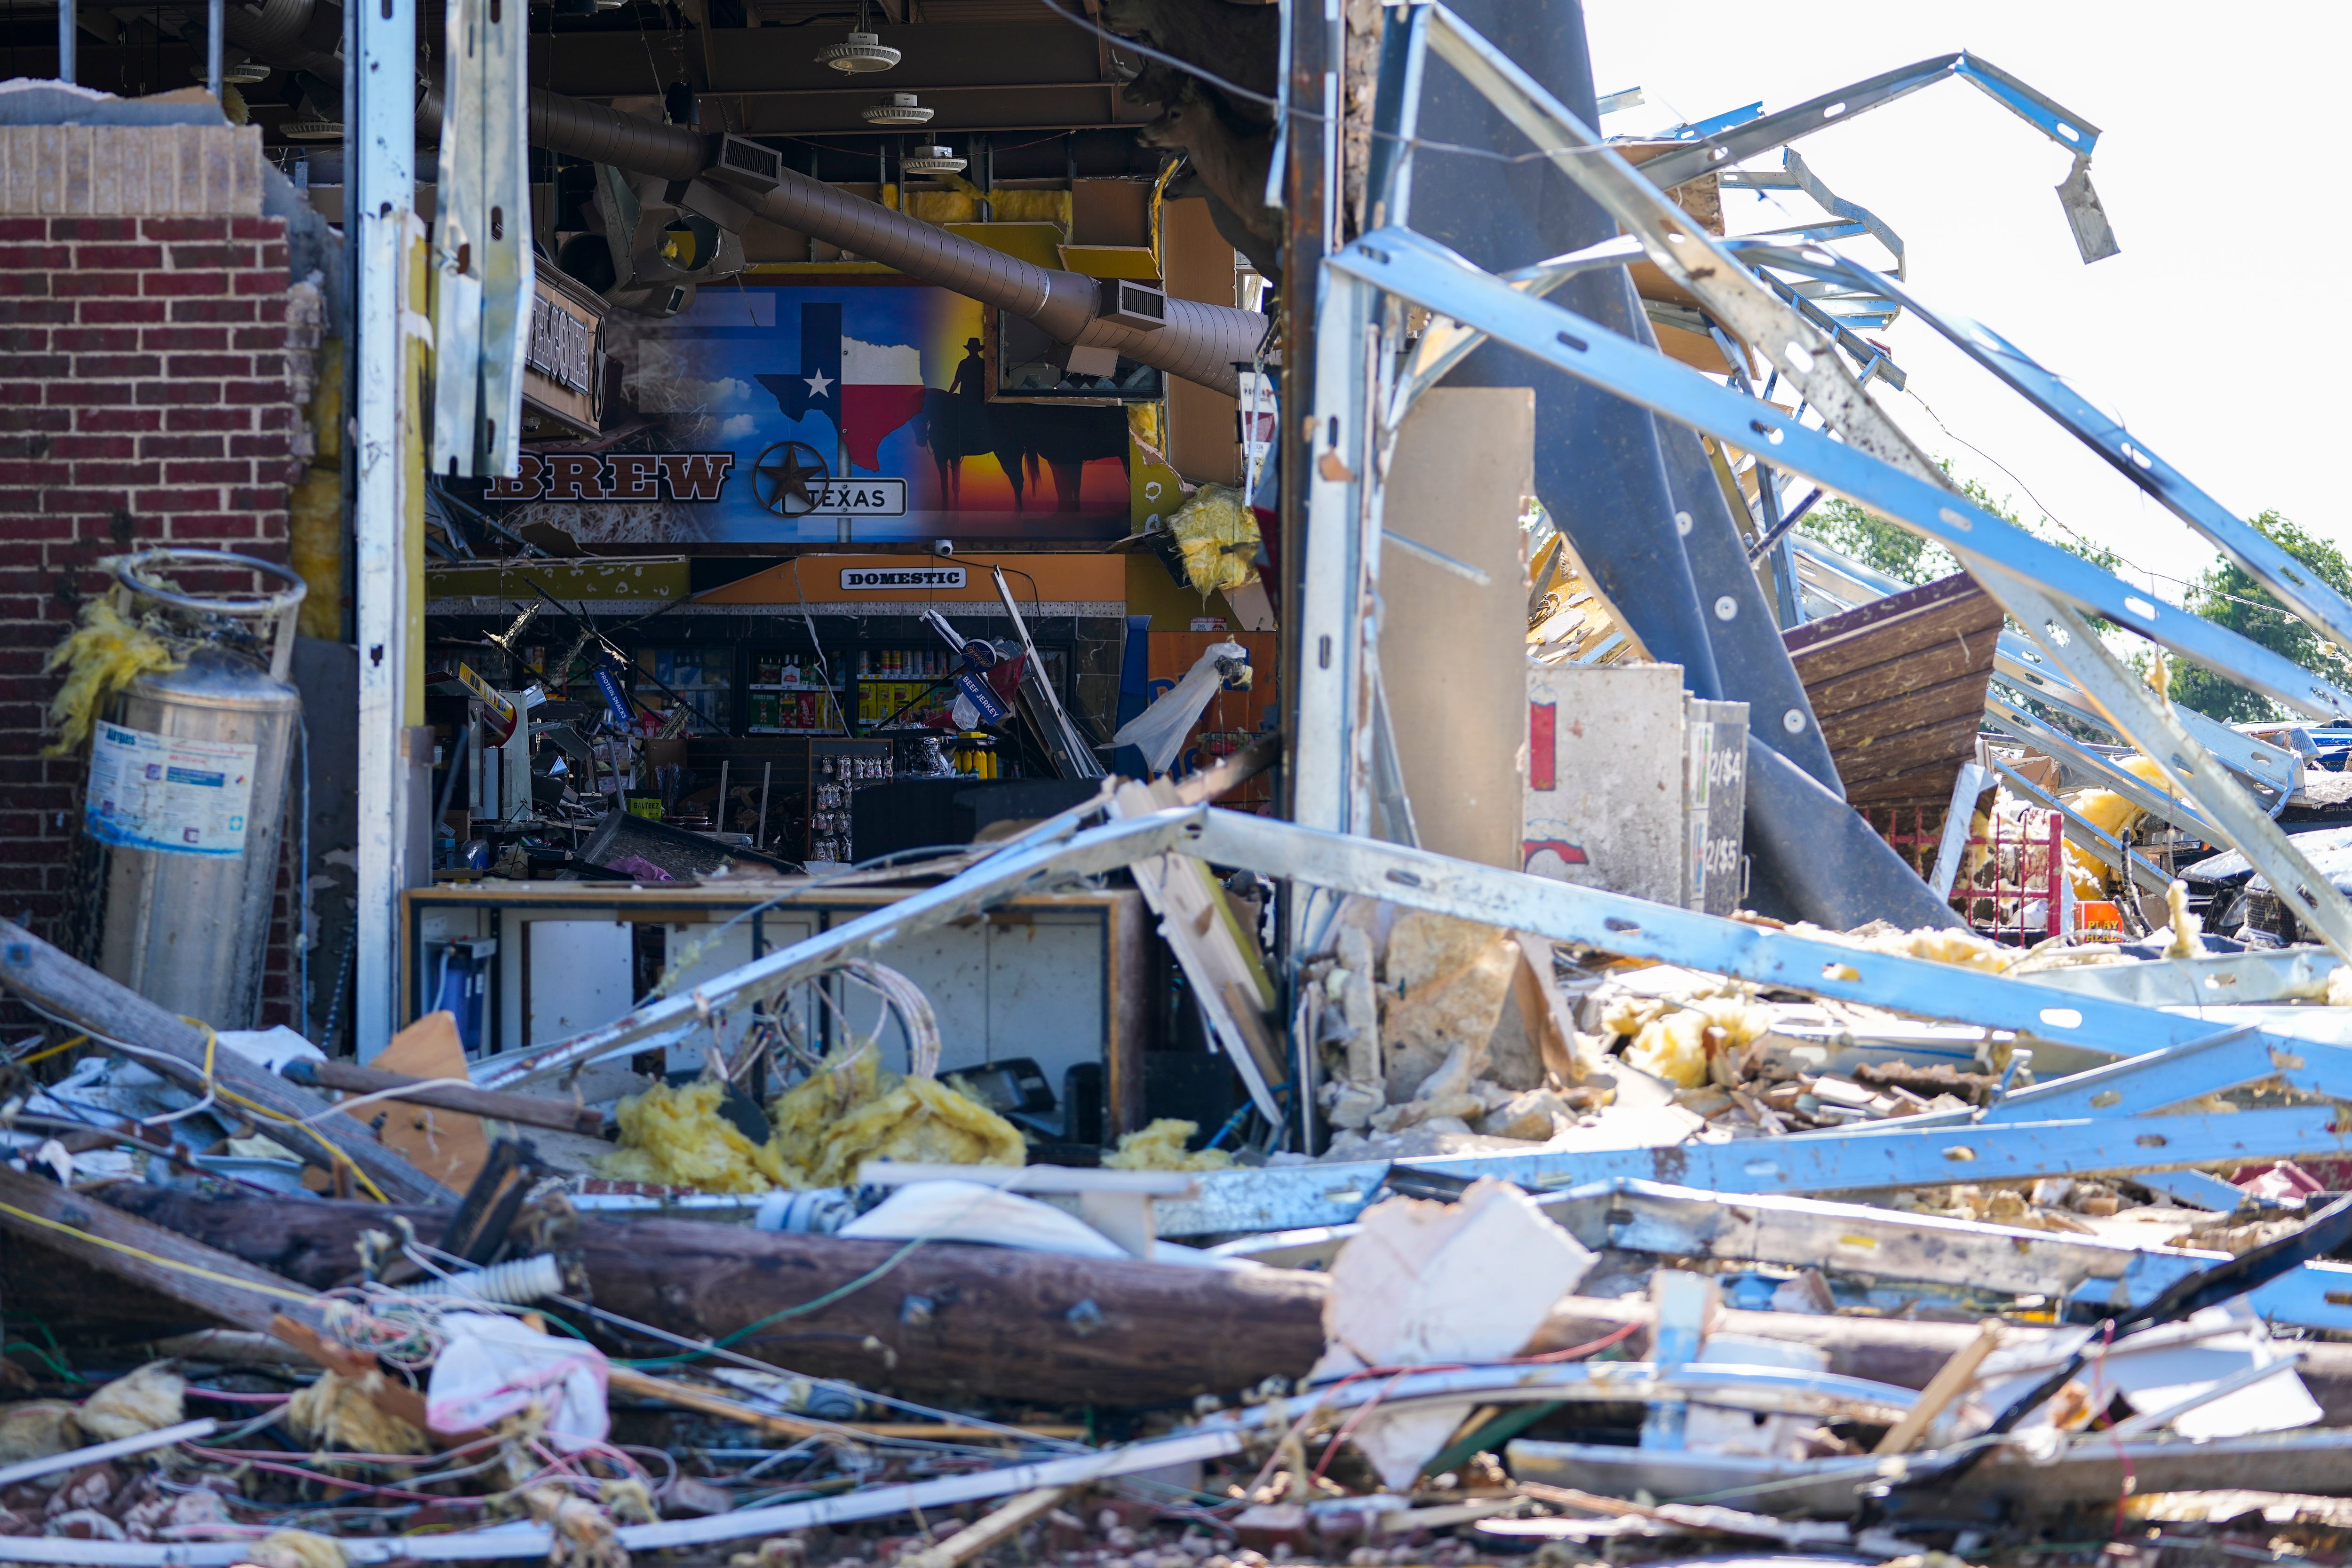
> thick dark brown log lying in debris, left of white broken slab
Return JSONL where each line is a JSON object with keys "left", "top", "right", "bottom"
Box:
{"left": 108, "top": 1182, "right": 1327, "bottom": 1406}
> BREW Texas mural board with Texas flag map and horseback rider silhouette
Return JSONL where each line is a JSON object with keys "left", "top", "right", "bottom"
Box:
{"left": 482, "top": 281, "right": 1141, "bottom": 546}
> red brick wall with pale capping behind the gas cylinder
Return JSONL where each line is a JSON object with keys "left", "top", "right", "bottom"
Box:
{"left": 0, "top": 127, "right": 318, "bottom": 1022}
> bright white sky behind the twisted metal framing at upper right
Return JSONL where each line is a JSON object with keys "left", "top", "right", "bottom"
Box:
{"left": 1585, "top": 0, "right": 2352, "bottom": 597}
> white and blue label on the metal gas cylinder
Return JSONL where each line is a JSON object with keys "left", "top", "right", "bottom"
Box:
{"left": 82, "top": 724, "right": 261, "bottom": 858}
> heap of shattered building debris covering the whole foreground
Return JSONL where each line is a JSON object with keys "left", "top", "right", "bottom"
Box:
{"left": 14, "top": 806, "right": 2352, "bottom": 1568}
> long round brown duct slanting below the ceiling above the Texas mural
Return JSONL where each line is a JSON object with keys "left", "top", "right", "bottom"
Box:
{"left": 532, "top": 89, "right": 1268, "bottom": 395}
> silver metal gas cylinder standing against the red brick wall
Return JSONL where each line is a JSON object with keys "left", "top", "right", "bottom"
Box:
{"left": 82, "top": 550, "right": 303, "bottom": 1029}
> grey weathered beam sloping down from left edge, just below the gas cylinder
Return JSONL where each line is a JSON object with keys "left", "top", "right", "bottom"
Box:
{"left": 0, "top": 919, "right": 456, "bottom": 1204}
